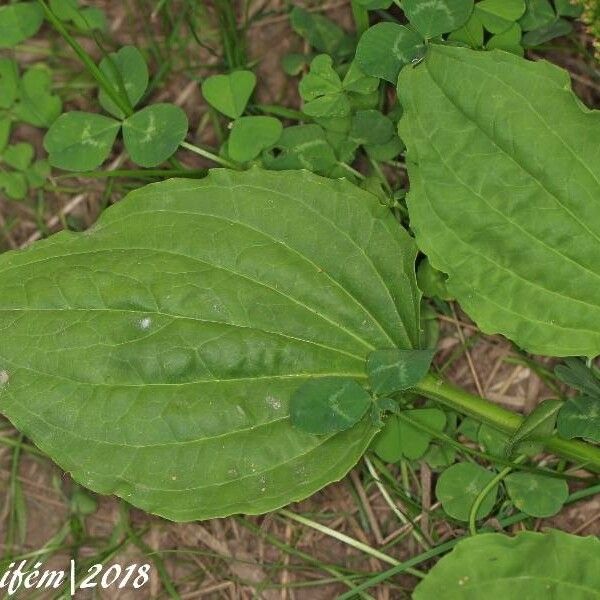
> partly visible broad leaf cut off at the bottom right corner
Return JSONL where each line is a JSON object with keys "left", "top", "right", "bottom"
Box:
{"left": 413, "top": 530, "right": 600, "bottom": 600}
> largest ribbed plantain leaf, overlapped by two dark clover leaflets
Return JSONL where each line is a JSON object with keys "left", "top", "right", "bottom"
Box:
{"left": 0, "top": 170, "right": 419, "bottom": 520}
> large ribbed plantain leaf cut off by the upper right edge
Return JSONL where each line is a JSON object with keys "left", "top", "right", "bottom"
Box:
{"left": 398, "top": 45, "right": 600, "bottom": 356}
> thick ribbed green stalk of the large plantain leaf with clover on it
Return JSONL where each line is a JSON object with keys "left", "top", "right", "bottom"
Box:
{"left": 416, "top": 373, "right": 600, "bottom": 471}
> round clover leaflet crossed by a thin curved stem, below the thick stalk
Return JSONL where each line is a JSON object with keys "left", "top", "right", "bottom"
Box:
{"left": 435, "top": 462, "right": 498, "bottom": 521}
